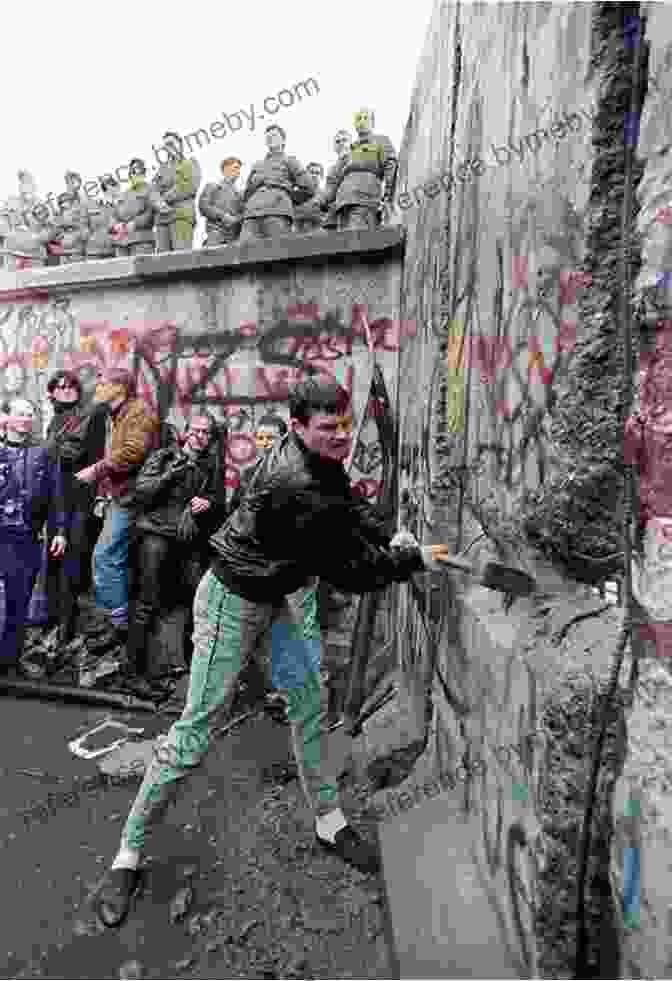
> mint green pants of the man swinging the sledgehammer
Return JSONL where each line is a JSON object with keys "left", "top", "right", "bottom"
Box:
{"left": 122, "top": 571, "right": 348, "bottom": 849}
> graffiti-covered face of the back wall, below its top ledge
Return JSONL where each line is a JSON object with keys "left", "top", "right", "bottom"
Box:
{"left": 0, "top": 257, "right": 414, "bottom": 680}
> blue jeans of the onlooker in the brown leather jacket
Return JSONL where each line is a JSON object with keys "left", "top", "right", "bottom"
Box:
{"left": 93, "top": 501, "right": 130, "bottom": 627}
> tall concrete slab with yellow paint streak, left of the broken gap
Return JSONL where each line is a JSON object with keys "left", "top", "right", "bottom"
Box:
{"left": 388, "top": 3, "right": 595, "bottom": 977}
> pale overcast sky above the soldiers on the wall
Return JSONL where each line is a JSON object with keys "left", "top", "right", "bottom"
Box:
{"left": 0, "top": 0, "right": 434, "bottom": 223}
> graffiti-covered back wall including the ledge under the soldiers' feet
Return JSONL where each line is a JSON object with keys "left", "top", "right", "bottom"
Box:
{"left": 9, "top": 229, "right": 414, "bottom": 663}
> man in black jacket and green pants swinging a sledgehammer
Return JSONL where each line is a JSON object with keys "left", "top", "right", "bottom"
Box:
{"left": 96, "top": 379, "right": 449, "bottom": 927}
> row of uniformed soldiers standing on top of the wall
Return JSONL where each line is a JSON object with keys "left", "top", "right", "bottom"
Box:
{"left": 2, "top": 109, "right": 397, "bottom": 269}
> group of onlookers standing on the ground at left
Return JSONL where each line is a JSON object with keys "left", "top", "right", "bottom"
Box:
{"left": 0, "top": 369, "right": 286, "bottom": 698}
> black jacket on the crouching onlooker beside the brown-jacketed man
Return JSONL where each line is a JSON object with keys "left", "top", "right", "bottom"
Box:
{"left": 133, "top": 444, "right": 226, "bottom": 540}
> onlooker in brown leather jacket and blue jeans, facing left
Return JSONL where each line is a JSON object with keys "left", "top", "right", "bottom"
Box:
{"left": 75, "top": 368, "right": 159, "bottom": 641}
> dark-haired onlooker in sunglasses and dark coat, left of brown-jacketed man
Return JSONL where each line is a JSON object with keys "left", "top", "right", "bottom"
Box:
{"left": 45, "top": 371, "right": 106, "bottom": 644}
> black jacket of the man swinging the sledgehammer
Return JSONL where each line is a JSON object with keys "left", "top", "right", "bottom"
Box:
{"left": 210, "top": 433, "right": 424, "bottom": 603}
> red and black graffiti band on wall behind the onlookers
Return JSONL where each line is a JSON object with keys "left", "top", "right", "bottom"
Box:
{"left": 0, "top": 297, "right": 414, "bottom": 499}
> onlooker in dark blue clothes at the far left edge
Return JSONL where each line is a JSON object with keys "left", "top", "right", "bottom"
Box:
{"left": 0, "top": 398, "right": 67, "bottom": 674}
